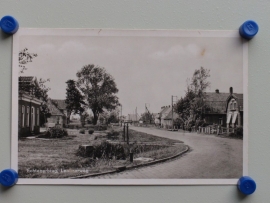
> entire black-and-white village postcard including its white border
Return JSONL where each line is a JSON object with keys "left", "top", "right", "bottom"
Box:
{"left": 11, "top": 28, "right": 248, "bottom": 185}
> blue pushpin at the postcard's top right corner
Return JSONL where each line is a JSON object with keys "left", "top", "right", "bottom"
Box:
{"left": 239, "top": 20, "right": 259, "bottom": 39}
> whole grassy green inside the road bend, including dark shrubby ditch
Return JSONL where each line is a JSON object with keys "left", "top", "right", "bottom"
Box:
{"left": 19, "top": 125, "right": 186, "bottom": 178}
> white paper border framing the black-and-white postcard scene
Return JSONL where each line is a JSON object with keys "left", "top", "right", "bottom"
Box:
{"left": 11, "top": 28, "right": 248, "bottom": 185}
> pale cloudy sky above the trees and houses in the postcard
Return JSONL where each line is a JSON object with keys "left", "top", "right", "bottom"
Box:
{"left": 18, "top": 32, "right": 243, "bottom": 115}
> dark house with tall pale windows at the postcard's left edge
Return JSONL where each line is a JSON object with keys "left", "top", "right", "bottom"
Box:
{"left": 18, "top": 76, "right": 43, "bottom": 136}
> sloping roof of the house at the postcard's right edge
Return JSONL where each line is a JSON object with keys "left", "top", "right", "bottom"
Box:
{"left": 205, "top": 92, "right": 243, "bottom": 113}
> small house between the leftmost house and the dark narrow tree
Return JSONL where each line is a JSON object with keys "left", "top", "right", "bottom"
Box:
{"left": 47, "top": 98, "right": 67, "bottom": 127}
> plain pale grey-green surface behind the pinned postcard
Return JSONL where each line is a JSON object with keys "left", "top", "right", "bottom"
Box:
{"left": 0, "top": 0, "right": 270, "bottom": 203}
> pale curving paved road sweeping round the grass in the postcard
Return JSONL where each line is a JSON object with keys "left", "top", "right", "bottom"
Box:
{"left": 92, "top": 126, "right": 243, "bottom": 179}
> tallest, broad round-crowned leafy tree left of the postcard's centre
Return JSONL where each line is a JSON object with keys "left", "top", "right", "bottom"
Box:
{"left": 76, "top": 64, "right": 119, "bottom": 125}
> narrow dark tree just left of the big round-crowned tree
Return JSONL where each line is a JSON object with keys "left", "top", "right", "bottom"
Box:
{"left": 65, "top": 80, "right": 85, "bottom": 123}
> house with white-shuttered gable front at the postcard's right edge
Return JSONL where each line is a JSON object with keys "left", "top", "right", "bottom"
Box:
{"left": 203, "top": 87, "right": 243, "bottom": 128}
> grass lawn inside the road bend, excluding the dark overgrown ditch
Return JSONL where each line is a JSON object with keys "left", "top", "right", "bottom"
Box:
{"left": 19, "top": 127, "right": 185, "bottom": 178}
